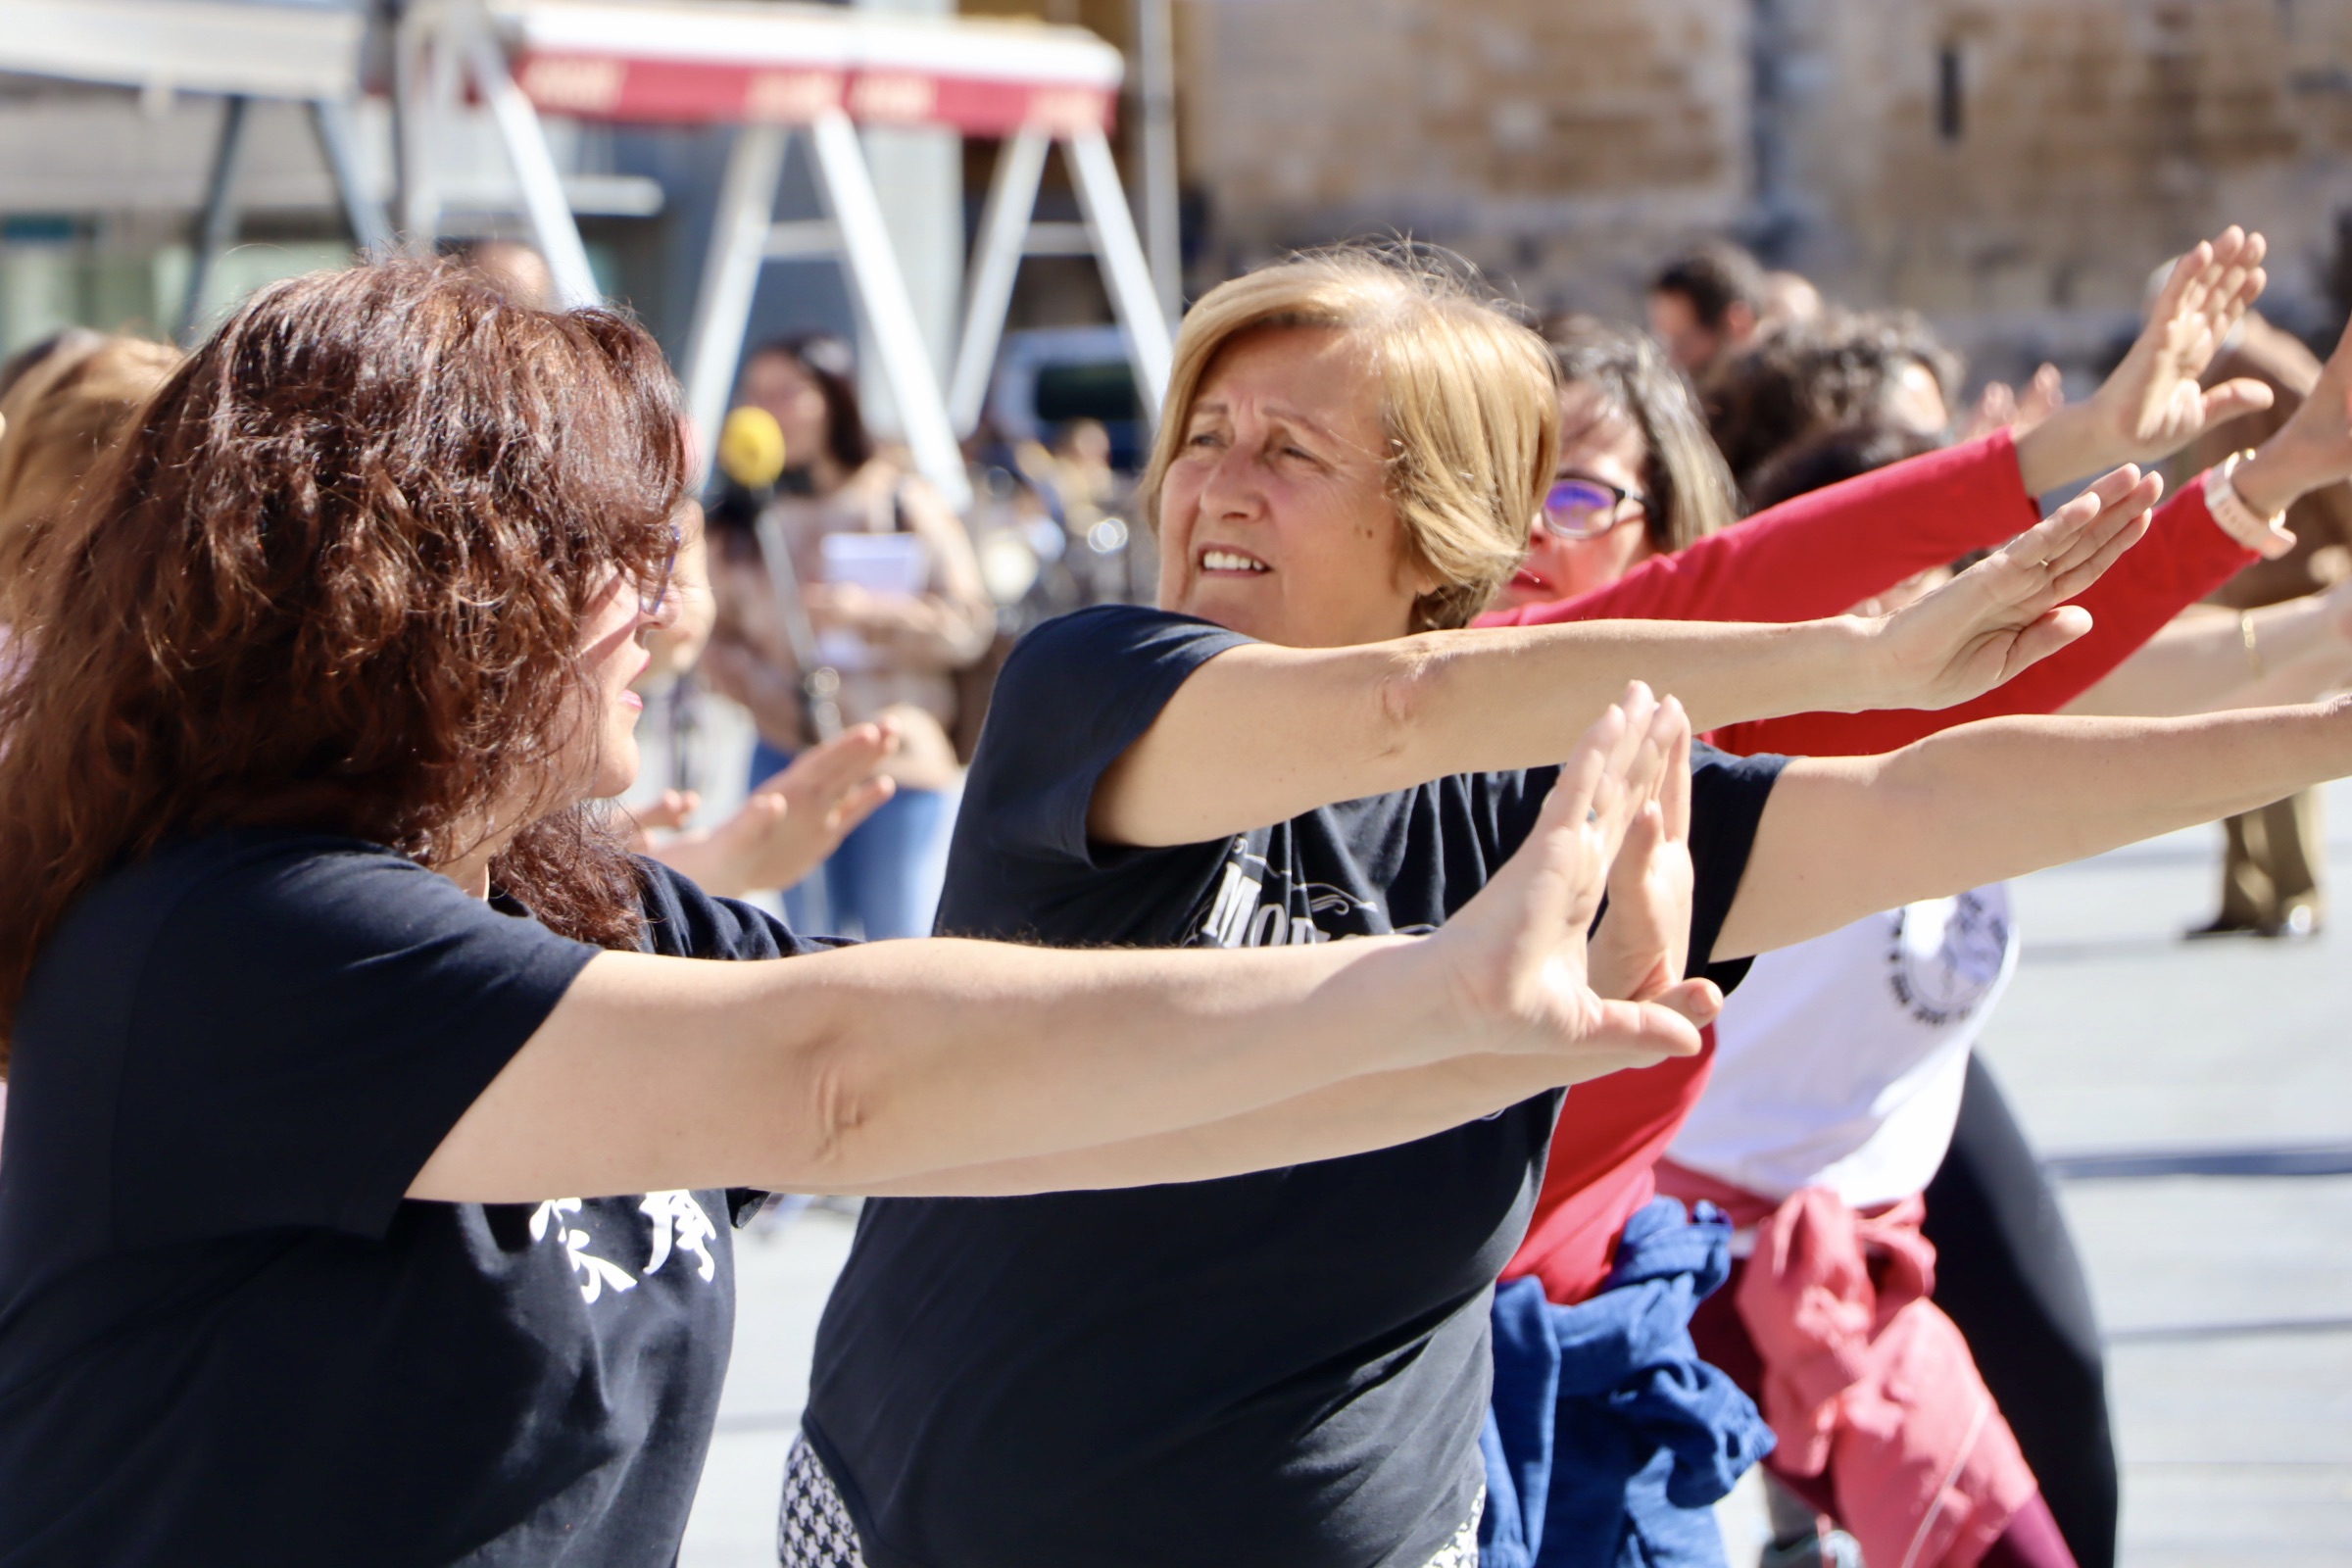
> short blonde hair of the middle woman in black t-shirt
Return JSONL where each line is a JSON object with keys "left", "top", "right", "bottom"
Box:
{"left": 1143, "top": 244, "right": 1559, "bottom": 630}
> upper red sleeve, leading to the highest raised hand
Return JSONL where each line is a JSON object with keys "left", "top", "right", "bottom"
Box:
{"left": 1477, "top": 430, "right": 2039, "bottom": 625}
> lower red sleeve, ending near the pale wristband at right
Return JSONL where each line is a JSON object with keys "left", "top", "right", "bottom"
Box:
{"left": 1707, "top": 479, "right": 2256, "bottom": 757}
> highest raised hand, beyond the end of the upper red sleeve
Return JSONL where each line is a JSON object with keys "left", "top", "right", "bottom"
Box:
{"left": 2018, "top": 223, "right": 2270, "bottom": 491}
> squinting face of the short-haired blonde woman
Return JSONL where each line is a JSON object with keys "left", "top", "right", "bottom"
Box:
{"left": 1159, "top": 326, "right": 1437, "bottom": 649}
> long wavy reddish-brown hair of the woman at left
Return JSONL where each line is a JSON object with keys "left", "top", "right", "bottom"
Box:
{"left": 0, "top": 261, "right": 687, "bottom": 1074}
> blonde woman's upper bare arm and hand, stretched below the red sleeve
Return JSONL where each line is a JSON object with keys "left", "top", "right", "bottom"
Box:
{"left": 1089, "top": 467, "right": 2157, "bottom": 844}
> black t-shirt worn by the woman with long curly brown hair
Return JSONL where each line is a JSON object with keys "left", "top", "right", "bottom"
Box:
{"left": 0, "top": 830, "right": 827, "bottom": 1568}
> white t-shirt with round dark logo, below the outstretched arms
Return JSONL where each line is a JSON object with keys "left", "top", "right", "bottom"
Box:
{"left": 1665, "top": 884, "right": 2018, "bottom": 1208}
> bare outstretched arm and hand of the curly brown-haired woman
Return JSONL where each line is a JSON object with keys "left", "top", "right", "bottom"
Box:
{"left": 410, "top": 694, "right": 1698, "bottom": 1201}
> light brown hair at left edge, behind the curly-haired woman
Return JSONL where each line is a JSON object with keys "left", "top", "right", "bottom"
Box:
{"left": 0, "top": 331, "right": 181, "bottom": 620}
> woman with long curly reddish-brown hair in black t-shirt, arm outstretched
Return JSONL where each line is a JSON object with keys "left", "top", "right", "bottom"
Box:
{"left": 0, "top": 264, "right": 1712, "bottom": 1566}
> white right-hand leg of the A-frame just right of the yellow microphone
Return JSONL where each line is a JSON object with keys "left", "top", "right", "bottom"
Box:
{"left": 809, "top": 108, "right": 973, "bottom": 513}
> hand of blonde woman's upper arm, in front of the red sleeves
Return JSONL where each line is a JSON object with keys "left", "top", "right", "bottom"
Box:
{"left": 1870, "top": 464, "right": 2164, "bottom": 708}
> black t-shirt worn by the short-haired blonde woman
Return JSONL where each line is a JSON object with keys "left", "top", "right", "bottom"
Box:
{"left": 805, "top": 607, "right": 1781, "bottom": 1568}
